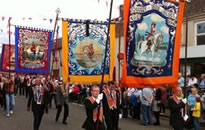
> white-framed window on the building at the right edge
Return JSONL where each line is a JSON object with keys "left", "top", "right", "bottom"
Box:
{"left": 195, "top": 21, "right": 205, "bottom": 45}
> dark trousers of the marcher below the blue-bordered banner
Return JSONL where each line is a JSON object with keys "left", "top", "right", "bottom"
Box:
{"left": 33, "top": 108, "right": 44, "bottom": 130}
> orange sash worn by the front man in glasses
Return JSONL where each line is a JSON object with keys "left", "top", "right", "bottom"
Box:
{"left": 88, "top": 97, "right": 103, "bottom": 122}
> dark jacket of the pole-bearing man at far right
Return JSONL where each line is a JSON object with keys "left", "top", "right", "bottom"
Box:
{"left": 168, "top": 98, "right": 185, "bottom": 127}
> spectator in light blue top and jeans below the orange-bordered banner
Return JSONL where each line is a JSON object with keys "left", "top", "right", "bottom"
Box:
{"left": 140, "top": 88, "right": 153, "bottom": 126}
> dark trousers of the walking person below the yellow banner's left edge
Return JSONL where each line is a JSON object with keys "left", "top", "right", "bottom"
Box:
{"left": 56, "top": 103, "right": 69, "bottom": 122}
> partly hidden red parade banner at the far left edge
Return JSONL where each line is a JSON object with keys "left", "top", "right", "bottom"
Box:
{"left": 0, "top": 44, "right": 15, "bottom": 72}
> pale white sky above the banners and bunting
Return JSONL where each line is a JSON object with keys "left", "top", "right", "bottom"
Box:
{"left": 0, "top": 0, "right": 124, "bottom": 52}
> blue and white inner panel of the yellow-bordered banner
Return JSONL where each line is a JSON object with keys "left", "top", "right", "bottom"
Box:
{"left": 68, "top": 22, "right": 110, "bottom": 75}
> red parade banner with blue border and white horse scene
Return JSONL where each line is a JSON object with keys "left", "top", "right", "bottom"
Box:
{"left": 15, "top": 27, "right": 52, "bottom": 73}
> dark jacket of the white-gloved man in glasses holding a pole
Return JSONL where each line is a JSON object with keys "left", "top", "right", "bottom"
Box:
{"left": 82, "top": 99, "right": 105, "bottom": 130}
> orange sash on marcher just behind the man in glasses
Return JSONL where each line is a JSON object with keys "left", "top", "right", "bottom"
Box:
{"left": 104, "top": 89, "right": 117, "bottom": 109}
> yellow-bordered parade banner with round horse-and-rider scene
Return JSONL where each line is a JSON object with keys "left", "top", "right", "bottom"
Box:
{"left": 62, "top": 20, "right": 115, "bottom": 84}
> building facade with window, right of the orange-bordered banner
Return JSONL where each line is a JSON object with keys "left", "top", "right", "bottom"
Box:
{"left": 180, "top": 0, "right": 205, "bottom": 77}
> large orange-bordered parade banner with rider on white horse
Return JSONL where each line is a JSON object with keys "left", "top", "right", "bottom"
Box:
{"left": 122, "top": 0, "right": 184, "bottom": 88}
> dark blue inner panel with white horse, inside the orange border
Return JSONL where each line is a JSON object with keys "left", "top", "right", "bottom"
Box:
{"left": 127, "top": 0, "right": 179, "bottom": 77}
